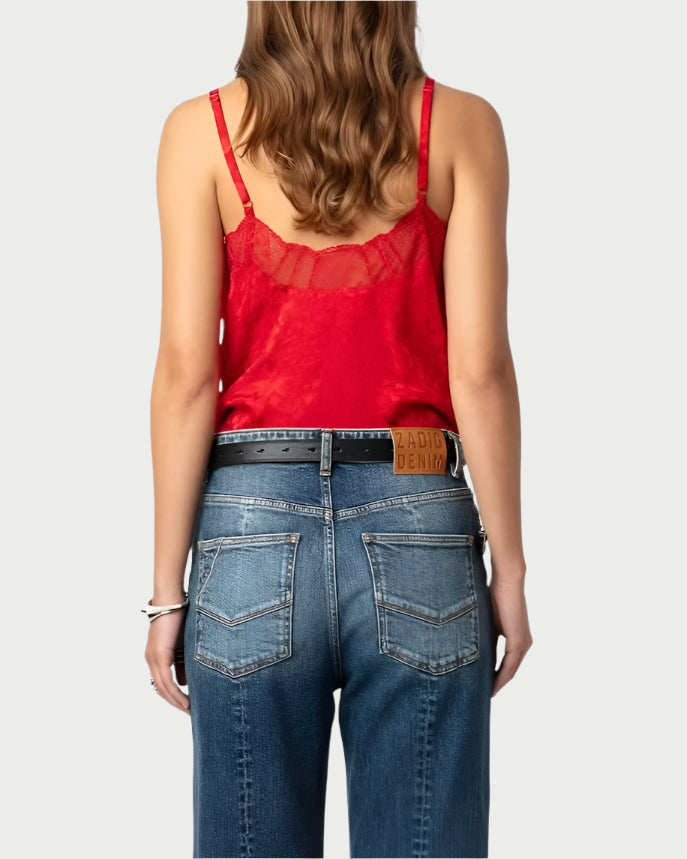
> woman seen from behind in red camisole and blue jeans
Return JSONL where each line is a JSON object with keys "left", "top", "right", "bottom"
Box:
{"left": 145, "top": 2, "right": 532, "bottom": 856}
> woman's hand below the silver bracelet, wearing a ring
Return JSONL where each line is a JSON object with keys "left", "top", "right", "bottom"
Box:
{"left": 145, "top": 607, "right": 191, "bottom": 715}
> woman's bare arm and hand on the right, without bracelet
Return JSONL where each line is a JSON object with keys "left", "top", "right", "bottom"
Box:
{"left": 444, "top": 92, "right": 532, "bottom": 695}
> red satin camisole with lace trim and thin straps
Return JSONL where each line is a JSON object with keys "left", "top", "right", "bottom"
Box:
{"left": 209, "top": 77, "right": 458, "bottom": 433}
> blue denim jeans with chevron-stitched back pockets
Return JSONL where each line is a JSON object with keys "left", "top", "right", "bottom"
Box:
{"left": 184, "top": 428, "right": 496, "bottom": 857}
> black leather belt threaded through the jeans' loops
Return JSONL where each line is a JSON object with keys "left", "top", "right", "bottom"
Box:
{"left": 208, "top": 433, "right": 456, "bottom": 474}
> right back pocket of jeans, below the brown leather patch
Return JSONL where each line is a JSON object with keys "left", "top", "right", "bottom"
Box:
{"left": 362, "top": 533, "right": 479, "bottom": 674}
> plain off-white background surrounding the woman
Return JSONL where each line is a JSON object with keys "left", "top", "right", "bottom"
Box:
{"left": 0, "top": 0, "right": 687, "bottom": 859}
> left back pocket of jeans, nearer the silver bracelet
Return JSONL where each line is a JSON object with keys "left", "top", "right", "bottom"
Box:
{"left": 195, "top": 533, "right": 300, "bottom": 677}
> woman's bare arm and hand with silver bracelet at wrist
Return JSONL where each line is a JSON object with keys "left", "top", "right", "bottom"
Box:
{"left": 145, "top": 92, "right": 226, "bottom": 711}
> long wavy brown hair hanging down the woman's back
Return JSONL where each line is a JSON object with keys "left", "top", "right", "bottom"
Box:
{"left": 235, "top": 0, "right": 425, "bottom": 235}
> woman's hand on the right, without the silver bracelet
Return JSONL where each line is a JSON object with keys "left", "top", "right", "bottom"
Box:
{"left": 489, "top": 573, "right": 532, "bottom": 698}
